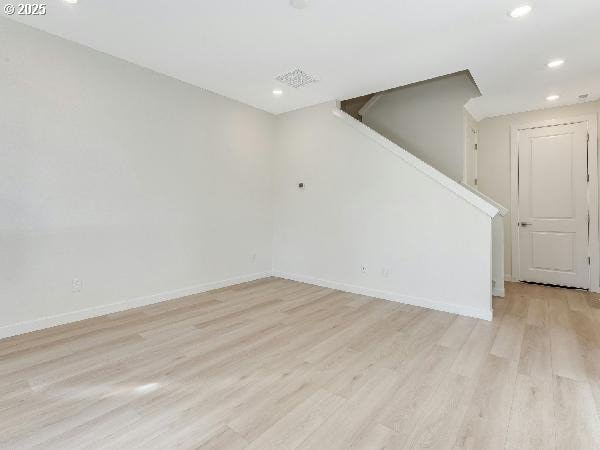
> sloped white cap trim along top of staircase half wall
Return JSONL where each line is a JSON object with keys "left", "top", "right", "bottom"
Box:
{"left": 332, "top": 109, "right": 498, "bottom": 217}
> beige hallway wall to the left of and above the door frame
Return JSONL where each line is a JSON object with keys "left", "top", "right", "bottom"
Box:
{"left": 477, "top": 101, "right": 600, "bottom": 274}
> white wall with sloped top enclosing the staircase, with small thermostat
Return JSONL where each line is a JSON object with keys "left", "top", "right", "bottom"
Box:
{"left": 273, "top": 104, "right": 491, "bottom": 317}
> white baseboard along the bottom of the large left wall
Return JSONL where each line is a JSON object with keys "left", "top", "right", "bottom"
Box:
{"left": 0, "top": 272, "right": 271, "bottom": 339}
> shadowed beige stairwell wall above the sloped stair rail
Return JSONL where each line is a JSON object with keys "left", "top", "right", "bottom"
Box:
{"left": 363, "top": 73, "right": 479, "bottom": 181}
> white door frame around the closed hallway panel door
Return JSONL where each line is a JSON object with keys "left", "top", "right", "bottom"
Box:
{"left": 510, "top": 114, "right": 600, "bottom": 293}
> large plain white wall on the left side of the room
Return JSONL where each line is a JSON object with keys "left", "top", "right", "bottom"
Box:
{"left": 0, "top": 19, "right": 275, "bottom": 337}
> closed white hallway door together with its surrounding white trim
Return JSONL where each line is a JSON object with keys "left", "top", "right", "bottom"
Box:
{"left": 511, "top": 117, "right": 600, "bottom": 291}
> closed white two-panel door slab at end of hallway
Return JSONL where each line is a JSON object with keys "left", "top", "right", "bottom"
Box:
{"left": 518, "top": 122, "right": 590, "bottom": 289}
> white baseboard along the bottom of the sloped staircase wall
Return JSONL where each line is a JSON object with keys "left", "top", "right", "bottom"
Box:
{"left": 272, "top": 271, "right": 492, "bottom": 320}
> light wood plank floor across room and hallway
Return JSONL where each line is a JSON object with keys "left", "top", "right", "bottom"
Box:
{"left": 0, "top": 278, "right": 600, "bottom": 450}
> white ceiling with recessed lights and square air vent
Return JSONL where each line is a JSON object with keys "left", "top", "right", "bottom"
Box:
{"left": 0, "top": 0, "right": 600, "bottom": 118}
